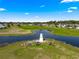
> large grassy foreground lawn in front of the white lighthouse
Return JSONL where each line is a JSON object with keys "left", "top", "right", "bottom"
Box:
{"left": 0, "top": 40, "right": 79, "bottom": 59}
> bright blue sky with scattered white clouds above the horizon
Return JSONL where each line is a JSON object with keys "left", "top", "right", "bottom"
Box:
{"left": 0, "top": 0, "right": 79, "bottom": 22}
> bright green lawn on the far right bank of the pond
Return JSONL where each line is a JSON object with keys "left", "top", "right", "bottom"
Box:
{"left": 51, "top": 27, "right": 79, "bottom": 36}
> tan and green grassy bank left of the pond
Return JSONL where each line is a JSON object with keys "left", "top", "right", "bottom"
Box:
{"left": 0, "top": 26, "right": 32, "bottom": 36}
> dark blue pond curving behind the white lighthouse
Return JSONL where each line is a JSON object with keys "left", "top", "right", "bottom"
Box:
{"left": 0, "top": 30, "right": 79, "bottom": 47}
